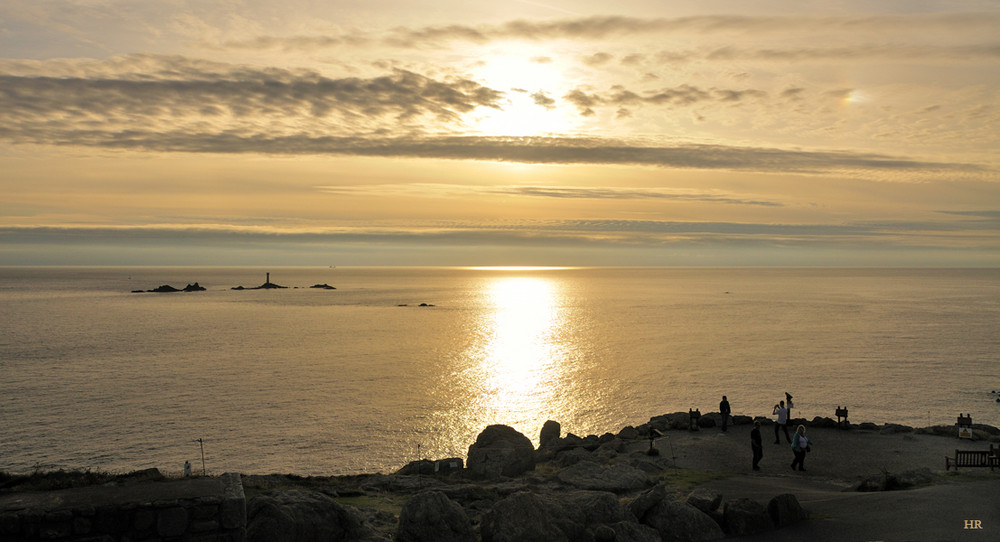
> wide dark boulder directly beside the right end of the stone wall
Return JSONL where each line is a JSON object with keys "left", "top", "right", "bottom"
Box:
{"left": 247, "top": 490, "right": 376, "bottom": 542}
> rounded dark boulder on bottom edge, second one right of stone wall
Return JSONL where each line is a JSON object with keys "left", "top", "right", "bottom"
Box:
{"left": 396, "top": 491, "right": 478, "bottom": 542}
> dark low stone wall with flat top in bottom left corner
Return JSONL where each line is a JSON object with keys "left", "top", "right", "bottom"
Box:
{"left": 0, "top": 473, "right": 247, "bottom": 542}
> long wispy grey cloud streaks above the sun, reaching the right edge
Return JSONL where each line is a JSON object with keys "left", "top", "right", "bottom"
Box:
{"left": 213, "top": 13, "right": 1000, "bottom": 51}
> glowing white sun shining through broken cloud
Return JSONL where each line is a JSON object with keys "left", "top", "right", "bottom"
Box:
{"left": 471, "top": 51, "right": 571, "bottom": 137}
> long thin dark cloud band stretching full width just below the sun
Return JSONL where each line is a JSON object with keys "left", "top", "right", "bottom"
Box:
{"left": 0, "top": 121, "right": 996, "bottom": 179}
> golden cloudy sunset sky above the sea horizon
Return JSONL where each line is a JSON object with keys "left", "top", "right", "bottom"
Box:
{"left": 0, "top": 0, "right": 1000, "bottom": 267}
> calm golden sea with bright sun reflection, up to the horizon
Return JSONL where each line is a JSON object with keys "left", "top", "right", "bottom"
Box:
{"left": 0, "top": 266, "right": 1000, "bottom": 476}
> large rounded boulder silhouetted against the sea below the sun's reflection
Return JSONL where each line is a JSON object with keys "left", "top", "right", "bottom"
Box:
{"left": 465, "top": 425, "right": 535, "bottom": 479}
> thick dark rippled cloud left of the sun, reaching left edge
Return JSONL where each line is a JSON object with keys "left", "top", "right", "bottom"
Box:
{"left": 0, "top": 64, "right": 503, "bottom": 135}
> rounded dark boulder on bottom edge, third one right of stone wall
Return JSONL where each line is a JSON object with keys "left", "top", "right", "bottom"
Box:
{"left": 479, "top": 491, "right": 570, "bottom": 542}
